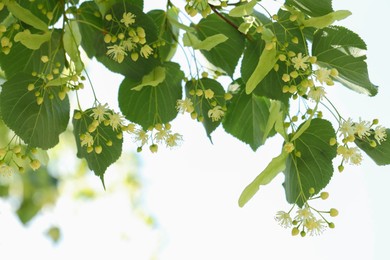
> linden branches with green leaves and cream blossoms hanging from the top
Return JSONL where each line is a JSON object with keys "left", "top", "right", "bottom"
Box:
{"left": 0, "top": 0, "right": 390, "bottom": 236}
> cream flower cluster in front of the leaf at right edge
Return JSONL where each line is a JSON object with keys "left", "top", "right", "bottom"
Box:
{"left": 336, "top": 118, "right": 387, "bottom": 169}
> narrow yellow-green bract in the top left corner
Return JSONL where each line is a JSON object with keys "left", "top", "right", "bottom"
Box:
{"left": 6, "top": 1, "right": 49, "bottom": 31}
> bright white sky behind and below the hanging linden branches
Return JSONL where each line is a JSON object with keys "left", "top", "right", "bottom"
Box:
{"left": 0, "top": 0, "right": 390, "bottom": 260}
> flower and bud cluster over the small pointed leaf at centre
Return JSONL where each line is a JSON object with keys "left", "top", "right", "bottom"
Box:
{"left": 176, "top": 76, "right": 233, "bottom": 122}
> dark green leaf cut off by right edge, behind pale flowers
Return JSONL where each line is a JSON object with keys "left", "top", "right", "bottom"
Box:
{"left": 355, "top": 128, "right": 390, "bottom": 165}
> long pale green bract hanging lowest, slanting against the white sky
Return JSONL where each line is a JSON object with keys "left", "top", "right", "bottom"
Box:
{"left": 238, "top": 151, "right": 288, "bottom": 207}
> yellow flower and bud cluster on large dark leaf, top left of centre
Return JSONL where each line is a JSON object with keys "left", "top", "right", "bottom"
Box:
{"left": 104, "top": 12, "right": 153, "bottom": 63}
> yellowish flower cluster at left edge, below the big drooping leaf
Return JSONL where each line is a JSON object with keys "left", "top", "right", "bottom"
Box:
{"left": 0, "top": 144, "right": 41, "bottom": 177}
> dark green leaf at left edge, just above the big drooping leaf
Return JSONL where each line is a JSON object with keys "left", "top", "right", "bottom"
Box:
{"left": 0, "top": 30, "right": 65, "bottom": 78}
